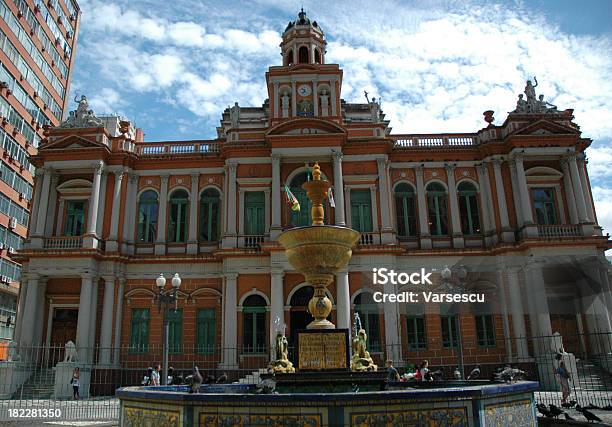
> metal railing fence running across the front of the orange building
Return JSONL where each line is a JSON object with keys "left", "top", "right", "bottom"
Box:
{"left": 0, "top": 334, "right": 612, "bottom": 422}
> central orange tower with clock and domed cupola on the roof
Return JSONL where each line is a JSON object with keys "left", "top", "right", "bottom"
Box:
{"left": 266, "top": 9, "right": 342, "bottom": 125}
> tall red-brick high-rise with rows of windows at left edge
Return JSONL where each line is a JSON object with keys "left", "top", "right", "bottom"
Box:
{"left": 0, "top": 0, "right": 80, "bottom": 340}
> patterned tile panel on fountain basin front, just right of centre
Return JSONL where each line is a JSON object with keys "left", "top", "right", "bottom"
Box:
{"left": 351, "top": 408, "right": 468, "bottom": 427}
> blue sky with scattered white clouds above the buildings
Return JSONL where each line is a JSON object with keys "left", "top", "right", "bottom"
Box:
{"left": 72, "top": 0, "right": 612, "bottom": 236}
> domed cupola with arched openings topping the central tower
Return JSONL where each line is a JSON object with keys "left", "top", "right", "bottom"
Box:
{"left": 280, "top": 8, "right": 327, "bottom": 66}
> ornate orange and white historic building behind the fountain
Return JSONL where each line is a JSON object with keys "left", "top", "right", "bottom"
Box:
{"left": 11, "top": 12, "right": 612, "bottom": 374}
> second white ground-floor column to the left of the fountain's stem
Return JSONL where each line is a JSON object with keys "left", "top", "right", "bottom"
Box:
{"left": 223, "top": 273, "right": 238, "bottom": 369}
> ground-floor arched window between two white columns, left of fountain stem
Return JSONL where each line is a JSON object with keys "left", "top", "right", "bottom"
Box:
{"left": 242, "top": 295, "right": 266, "bottom": 353}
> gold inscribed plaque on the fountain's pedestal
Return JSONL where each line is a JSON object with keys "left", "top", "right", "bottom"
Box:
{"left": 297, "top": 329, "right": 350, "bottom": 371}
